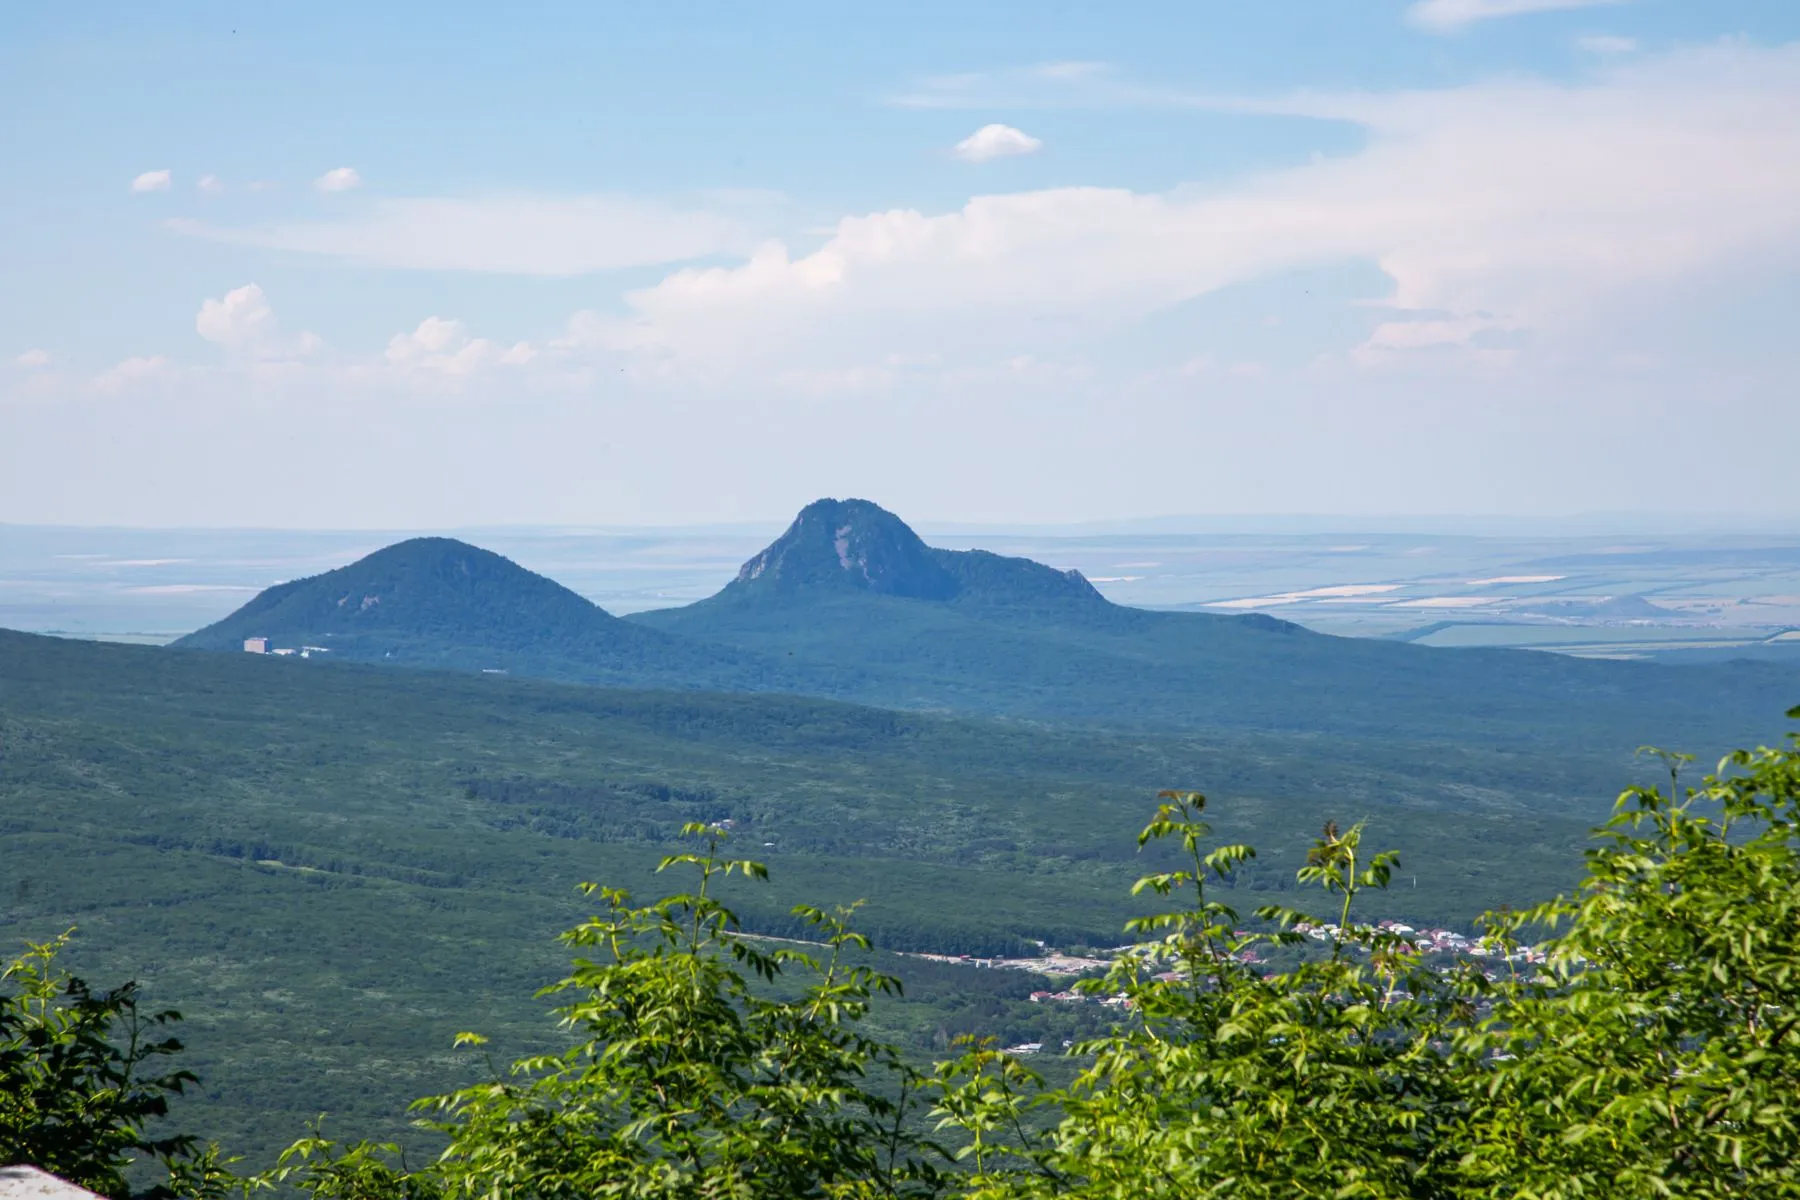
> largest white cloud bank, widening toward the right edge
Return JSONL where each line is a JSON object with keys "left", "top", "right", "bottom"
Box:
{"left": 569, "top": 43, "right": 1800, "bottom": 376}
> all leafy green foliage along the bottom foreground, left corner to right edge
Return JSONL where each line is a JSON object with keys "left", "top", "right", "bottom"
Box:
{"left": 10, "top": 709, "right": 1800, "bottom": 1200}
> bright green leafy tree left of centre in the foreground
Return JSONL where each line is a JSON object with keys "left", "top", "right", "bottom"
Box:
{"left": 272, "top": 826, "right": 941, "bottom": 1200}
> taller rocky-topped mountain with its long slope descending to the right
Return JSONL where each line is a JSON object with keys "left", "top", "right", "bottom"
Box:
{"left": 626, "top": 500, "right": 1800, "bottom": 747}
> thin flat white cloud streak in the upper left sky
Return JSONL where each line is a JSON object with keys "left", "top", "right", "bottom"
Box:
{"left": 173, "top": 196, "right": 749, "bottom": 275}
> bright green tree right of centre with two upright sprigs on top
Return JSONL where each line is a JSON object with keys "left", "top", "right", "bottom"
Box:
{"left": 940, "top": 792, "right": 1465, "bottom": 1200}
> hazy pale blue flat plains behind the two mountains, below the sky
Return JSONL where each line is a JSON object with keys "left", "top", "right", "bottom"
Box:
{"left": 10, "top": 513, "right": 1800, "bottom": 657}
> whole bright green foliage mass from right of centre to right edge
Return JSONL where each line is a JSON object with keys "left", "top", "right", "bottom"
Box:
{"left": 938, "top": 709, "right": 1800, "bottom": 1200}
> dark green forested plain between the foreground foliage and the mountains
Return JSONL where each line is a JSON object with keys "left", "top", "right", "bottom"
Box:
{"left": 0, "top": 633, "right": 1778, "bottom": 1160}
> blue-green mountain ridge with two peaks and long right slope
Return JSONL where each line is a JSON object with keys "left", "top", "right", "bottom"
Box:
{"left": 176, "top": 500, "right": 1800, "bottom": 752}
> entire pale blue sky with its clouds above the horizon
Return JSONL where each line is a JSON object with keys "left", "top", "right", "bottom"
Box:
{"left": 0, "top": 0, "right": 1800, "bottom": 527}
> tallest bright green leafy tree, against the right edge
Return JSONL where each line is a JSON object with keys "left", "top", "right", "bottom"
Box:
{"left": 1460, "top": 709, "right": 1800, "bottom": 1200}
